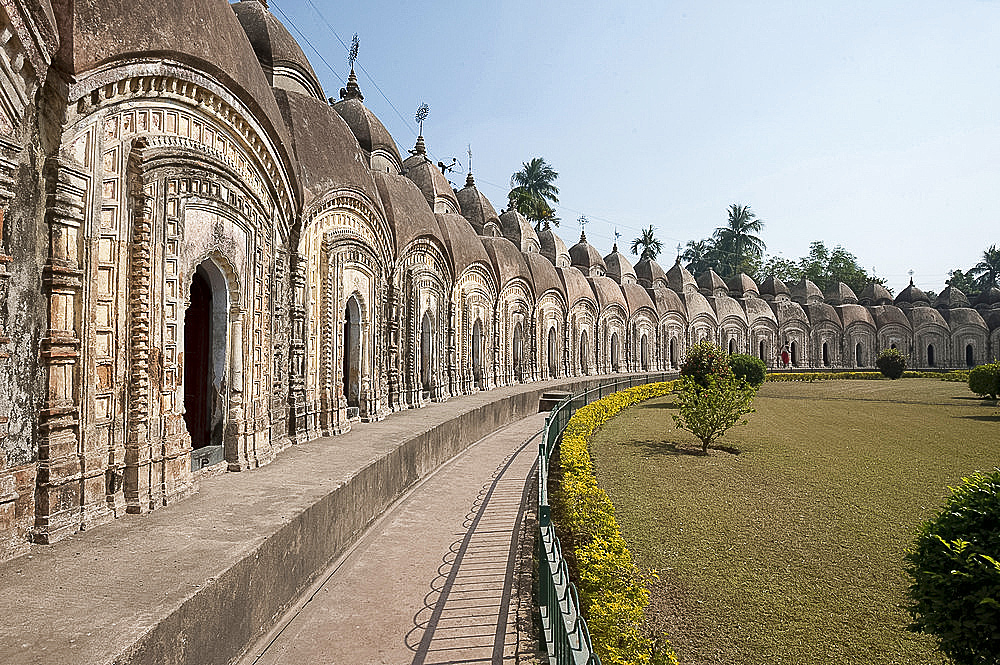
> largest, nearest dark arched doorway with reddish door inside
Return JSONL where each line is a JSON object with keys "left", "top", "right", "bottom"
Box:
{"left": 184, "top": 259, "right": 229, "bottom": 470}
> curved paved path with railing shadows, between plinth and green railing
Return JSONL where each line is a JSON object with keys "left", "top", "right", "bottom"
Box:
{"left": 242, "top": 414, "right": 545, "bottom": 665}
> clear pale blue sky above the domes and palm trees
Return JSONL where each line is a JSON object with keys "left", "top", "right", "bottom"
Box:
{"left": 262, "top": 0, "right": 1000, "bottom": 292}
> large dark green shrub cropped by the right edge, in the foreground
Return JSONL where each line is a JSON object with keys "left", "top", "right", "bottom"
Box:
{"left": 906, "top": 469, "right": 1000, "bottom": 665}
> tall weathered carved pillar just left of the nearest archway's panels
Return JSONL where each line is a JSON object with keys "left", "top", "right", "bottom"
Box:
{"left": 32, "top": 158, "right": 87, "bottom": 543}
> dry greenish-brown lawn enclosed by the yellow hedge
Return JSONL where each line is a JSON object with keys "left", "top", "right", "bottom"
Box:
{"left": 592, "top": 379, "right": 1000, "bottom": 665}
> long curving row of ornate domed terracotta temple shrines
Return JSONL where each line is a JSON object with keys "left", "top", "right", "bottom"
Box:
{"left": 0, "top": 0, "right": 1000, "bottom": 558}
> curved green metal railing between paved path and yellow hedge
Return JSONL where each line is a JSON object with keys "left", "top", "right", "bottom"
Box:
{"left": 535, "top": 372, "right": 672, "bottom": 665}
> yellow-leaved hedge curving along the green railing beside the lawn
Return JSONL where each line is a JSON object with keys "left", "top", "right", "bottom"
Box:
{"left": 552, "top": 381, "right": 677, "bottom": 665}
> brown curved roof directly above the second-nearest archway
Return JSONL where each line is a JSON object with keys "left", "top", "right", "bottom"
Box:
{"left": 274, "top": 90, "right": 379, "bottom": 204}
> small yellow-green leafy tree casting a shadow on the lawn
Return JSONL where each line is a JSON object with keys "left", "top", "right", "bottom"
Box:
{"left": 674, "top": 374, "right": 757, "bottom": 454}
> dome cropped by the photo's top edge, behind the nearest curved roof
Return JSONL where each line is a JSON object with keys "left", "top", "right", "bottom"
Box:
{"left": 231, "top": 0, "right": 326, "bottom": 102}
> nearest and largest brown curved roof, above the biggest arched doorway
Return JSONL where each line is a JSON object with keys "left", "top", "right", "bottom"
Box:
{"left": 53, "top": 0, "right": 295, "bottom": 196}
